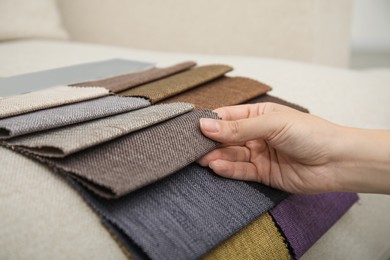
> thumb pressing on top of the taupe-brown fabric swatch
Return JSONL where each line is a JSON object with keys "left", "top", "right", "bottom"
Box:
{"left": 200, "top": 113, "right": 287, "bottom": 143}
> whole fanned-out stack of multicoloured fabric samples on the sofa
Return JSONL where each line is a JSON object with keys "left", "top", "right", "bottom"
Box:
{"left": 0, "top": 62, "right": 358, "bottom": 259}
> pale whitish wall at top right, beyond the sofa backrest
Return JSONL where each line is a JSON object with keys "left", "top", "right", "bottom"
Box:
{"left": 351, "top": 0, "right": 390, "bottom": 51}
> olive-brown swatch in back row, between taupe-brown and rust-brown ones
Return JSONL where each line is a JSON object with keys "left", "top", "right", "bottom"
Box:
{"left": 119, "top": 65, "right": 233, "bottom": 103}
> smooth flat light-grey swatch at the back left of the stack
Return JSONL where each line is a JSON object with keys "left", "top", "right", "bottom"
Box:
{"left": 0, "top": 59, "right": 153, "bottom": 97}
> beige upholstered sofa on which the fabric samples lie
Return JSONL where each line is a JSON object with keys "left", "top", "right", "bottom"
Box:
{"left": 0, "top": 0, "right": 390, "bottom": 259}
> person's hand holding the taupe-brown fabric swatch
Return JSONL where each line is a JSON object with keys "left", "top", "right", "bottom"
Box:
{"left": 198, "top": 103, "right": 390, "bottom": 193}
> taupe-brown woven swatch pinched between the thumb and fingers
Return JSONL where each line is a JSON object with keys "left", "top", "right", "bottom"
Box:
{"left": 14, "top": 110, "right": 218, "bottom": 198}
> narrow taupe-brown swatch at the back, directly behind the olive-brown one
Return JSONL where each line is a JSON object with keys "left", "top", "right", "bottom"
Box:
{"left": 72, "top": 61, "right": 196, "bottom": 93}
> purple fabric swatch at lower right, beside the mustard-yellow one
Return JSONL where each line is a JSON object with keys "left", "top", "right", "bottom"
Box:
{"left": 270, "top": 193, "right": 358, "bottom": 259}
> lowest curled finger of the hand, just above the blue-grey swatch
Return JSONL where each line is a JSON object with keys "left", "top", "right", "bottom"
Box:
{"left": 209, "top": 160, "right": 261, "bottom": 182}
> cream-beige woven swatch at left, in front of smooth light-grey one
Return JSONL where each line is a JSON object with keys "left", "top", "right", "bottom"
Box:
{"left": 0, "top": 86, "right": 109, "bottom": 118}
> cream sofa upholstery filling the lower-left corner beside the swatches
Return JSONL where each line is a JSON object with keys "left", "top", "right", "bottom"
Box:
{"left": 0, "top": 147, "right": 126, "bottom": 260}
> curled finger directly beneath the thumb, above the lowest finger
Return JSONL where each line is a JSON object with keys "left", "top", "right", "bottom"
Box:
{"left": 198, "top": 146, "right": 251, "bottom": 166}
